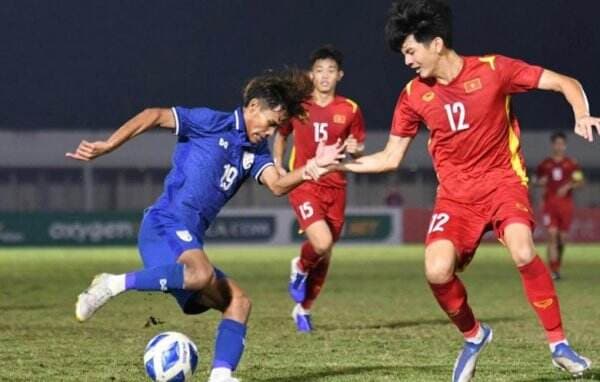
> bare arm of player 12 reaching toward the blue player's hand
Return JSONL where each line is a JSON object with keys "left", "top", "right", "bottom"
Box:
{"left": 337, "top": 135, "right": 413, "bottom": 173}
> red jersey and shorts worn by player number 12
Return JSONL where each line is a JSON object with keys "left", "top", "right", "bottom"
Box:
{"left": 391, "top": 55, "right": 543, "bottom": 266}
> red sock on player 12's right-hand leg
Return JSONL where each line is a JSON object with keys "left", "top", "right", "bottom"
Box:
{"left": 519, "top": 256, "right": 565, "bottom": 342}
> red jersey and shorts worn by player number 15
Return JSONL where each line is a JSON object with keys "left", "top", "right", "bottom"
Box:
{"left": 279, "top": 96, "right": 365, "bottom": 240}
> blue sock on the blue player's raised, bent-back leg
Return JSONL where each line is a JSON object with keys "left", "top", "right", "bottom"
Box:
{"left": 125, "top": 264, "right": 183, "bottom": 292}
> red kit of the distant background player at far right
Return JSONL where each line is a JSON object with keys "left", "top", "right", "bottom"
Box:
{"left": 537, "top": 157, "right": 583, "bottom": 232}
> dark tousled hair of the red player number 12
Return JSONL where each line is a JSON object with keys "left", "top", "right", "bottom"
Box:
{"left": 385, "top": 0, "right": 452, "bottom": 52}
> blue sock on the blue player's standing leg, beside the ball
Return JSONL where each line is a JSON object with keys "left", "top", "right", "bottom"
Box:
{"left": 212, "top": 319, "right": 246, "bottom": 370}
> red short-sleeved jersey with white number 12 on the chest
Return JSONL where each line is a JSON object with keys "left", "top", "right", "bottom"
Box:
{"left": 391, "top": 55, "right": 543, "bottom": 202}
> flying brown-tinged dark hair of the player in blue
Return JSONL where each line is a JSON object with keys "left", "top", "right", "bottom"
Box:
{"left": 243, "top": 69, "right": 313, "bottom": 118}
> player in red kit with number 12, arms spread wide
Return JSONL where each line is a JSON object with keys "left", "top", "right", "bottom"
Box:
{"left": 339, "top": 0, "right": 600, "bottom": 381}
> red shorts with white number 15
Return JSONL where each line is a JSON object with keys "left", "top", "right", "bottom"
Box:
{"left": 289, "top": 182, "right": 346, "bottom": 241}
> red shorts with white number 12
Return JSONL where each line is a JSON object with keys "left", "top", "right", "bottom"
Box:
{"left": 425, "top": 183, "right": 535, "bottom": 269}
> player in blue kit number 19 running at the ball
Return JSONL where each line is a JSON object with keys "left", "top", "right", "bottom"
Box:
{"left": 66, "top": 70, "right": 344, "bottom": 382}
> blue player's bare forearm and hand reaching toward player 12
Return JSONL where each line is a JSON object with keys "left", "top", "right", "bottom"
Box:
{"left": 260, "top": 140, "right": 345, "bottom": 196}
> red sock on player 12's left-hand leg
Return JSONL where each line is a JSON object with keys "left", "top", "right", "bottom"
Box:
{"left": 429, "top": 276, "right": 479, "bottom": 337}
